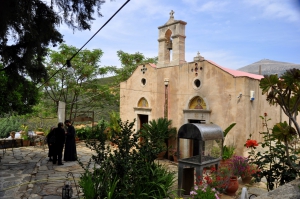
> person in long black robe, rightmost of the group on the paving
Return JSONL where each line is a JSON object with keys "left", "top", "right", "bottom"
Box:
{"left": 64, "top": 120, "right": 77, "bottom": 161}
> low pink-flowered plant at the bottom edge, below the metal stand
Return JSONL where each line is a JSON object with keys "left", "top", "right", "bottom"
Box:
{"left": 190, "top": 185, "right": 220, "bottom": 199}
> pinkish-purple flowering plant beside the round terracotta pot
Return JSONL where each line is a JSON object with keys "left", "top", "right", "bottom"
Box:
{"left": 232, "top": 156, "right": 259, "bottom": 177}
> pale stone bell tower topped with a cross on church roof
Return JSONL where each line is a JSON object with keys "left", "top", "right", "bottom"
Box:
{"left": 157, "top": 10, "right": 186, "bottom": 68}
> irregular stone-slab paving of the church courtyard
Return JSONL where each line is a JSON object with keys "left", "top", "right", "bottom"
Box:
{"left": 0, "top": 142, "right": 266, "bottom": 199}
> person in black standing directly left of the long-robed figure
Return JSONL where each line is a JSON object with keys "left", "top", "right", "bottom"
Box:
{"left": 53, "top": 122, "right": 66, "bottom": 165}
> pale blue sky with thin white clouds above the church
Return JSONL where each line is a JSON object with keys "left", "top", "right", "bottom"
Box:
{"left": 55, "top": 0, "right": 300, "bottom": 69}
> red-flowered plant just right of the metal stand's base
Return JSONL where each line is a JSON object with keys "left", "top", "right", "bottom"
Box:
{"left": 195, "top": 166, "right": 232, "bottom": 193}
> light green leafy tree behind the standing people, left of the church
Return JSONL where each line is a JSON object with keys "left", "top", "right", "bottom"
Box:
{"left": 44, "top": 44, "right": 113, "bottom": 121}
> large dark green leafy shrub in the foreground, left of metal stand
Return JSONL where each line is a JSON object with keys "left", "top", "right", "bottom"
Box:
{"left": 80, "top": 121, "right": 175, "bottom": 199}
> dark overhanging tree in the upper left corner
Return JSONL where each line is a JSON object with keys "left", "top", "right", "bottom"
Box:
{"left": 0, "top": 0, "right": 105, "bottom": 114}
